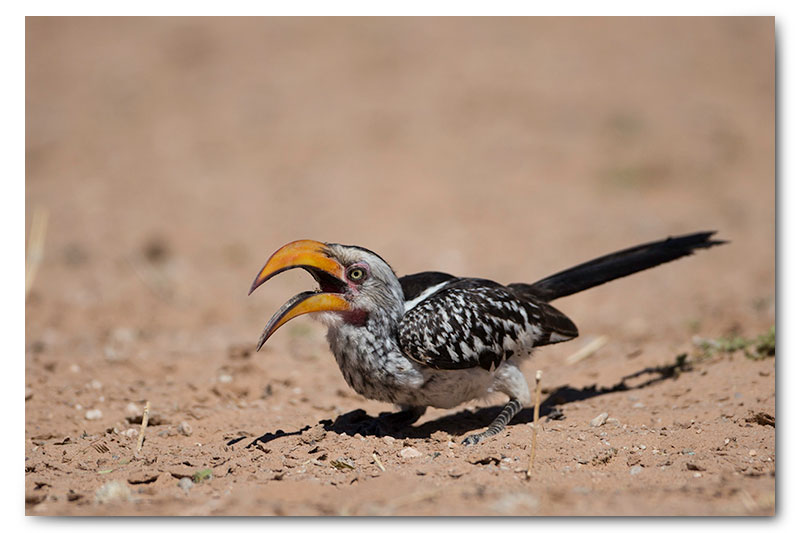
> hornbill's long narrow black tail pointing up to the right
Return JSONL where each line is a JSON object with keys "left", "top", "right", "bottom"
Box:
{"left": 514, "top": 231, "right": 728, "bottom": 302}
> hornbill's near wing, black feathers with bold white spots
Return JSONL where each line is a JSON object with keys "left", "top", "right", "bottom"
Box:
{"left": 397, "top": 273, "right": 578, "bottom": 370}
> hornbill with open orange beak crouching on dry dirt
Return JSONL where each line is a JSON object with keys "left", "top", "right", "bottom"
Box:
{"left": 248, "top": 231, "right": 727, "bottom": 445}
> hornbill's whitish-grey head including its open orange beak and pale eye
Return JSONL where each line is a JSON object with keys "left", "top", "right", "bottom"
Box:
{"left": 250, "top": 240, "right": 403, "bottom": 349}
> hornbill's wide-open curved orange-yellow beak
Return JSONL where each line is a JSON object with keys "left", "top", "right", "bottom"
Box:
{"left": 248, "top": 240, "right": 350, "bottom": 350}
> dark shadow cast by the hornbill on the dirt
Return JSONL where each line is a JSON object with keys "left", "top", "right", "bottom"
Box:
{"left": 320, "top": 355, "right": 691, "bottom": 439}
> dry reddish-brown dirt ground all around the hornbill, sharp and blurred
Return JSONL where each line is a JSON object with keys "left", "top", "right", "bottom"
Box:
{"left": 25, "top": 18, "right": 775, "bottom": 515}
